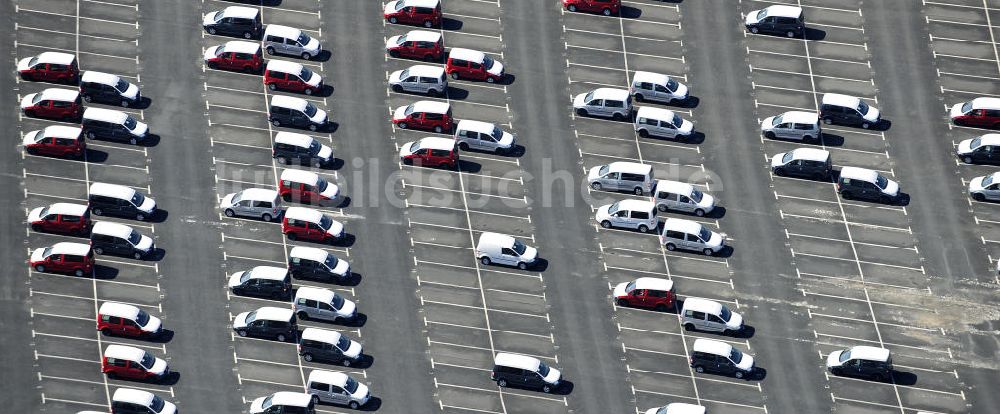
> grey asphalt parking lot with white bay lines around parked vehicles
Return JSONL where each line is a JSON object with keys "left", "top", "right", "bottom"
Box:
{"left": 0, "top": 0, "right": 1000, "bottom": 414}
